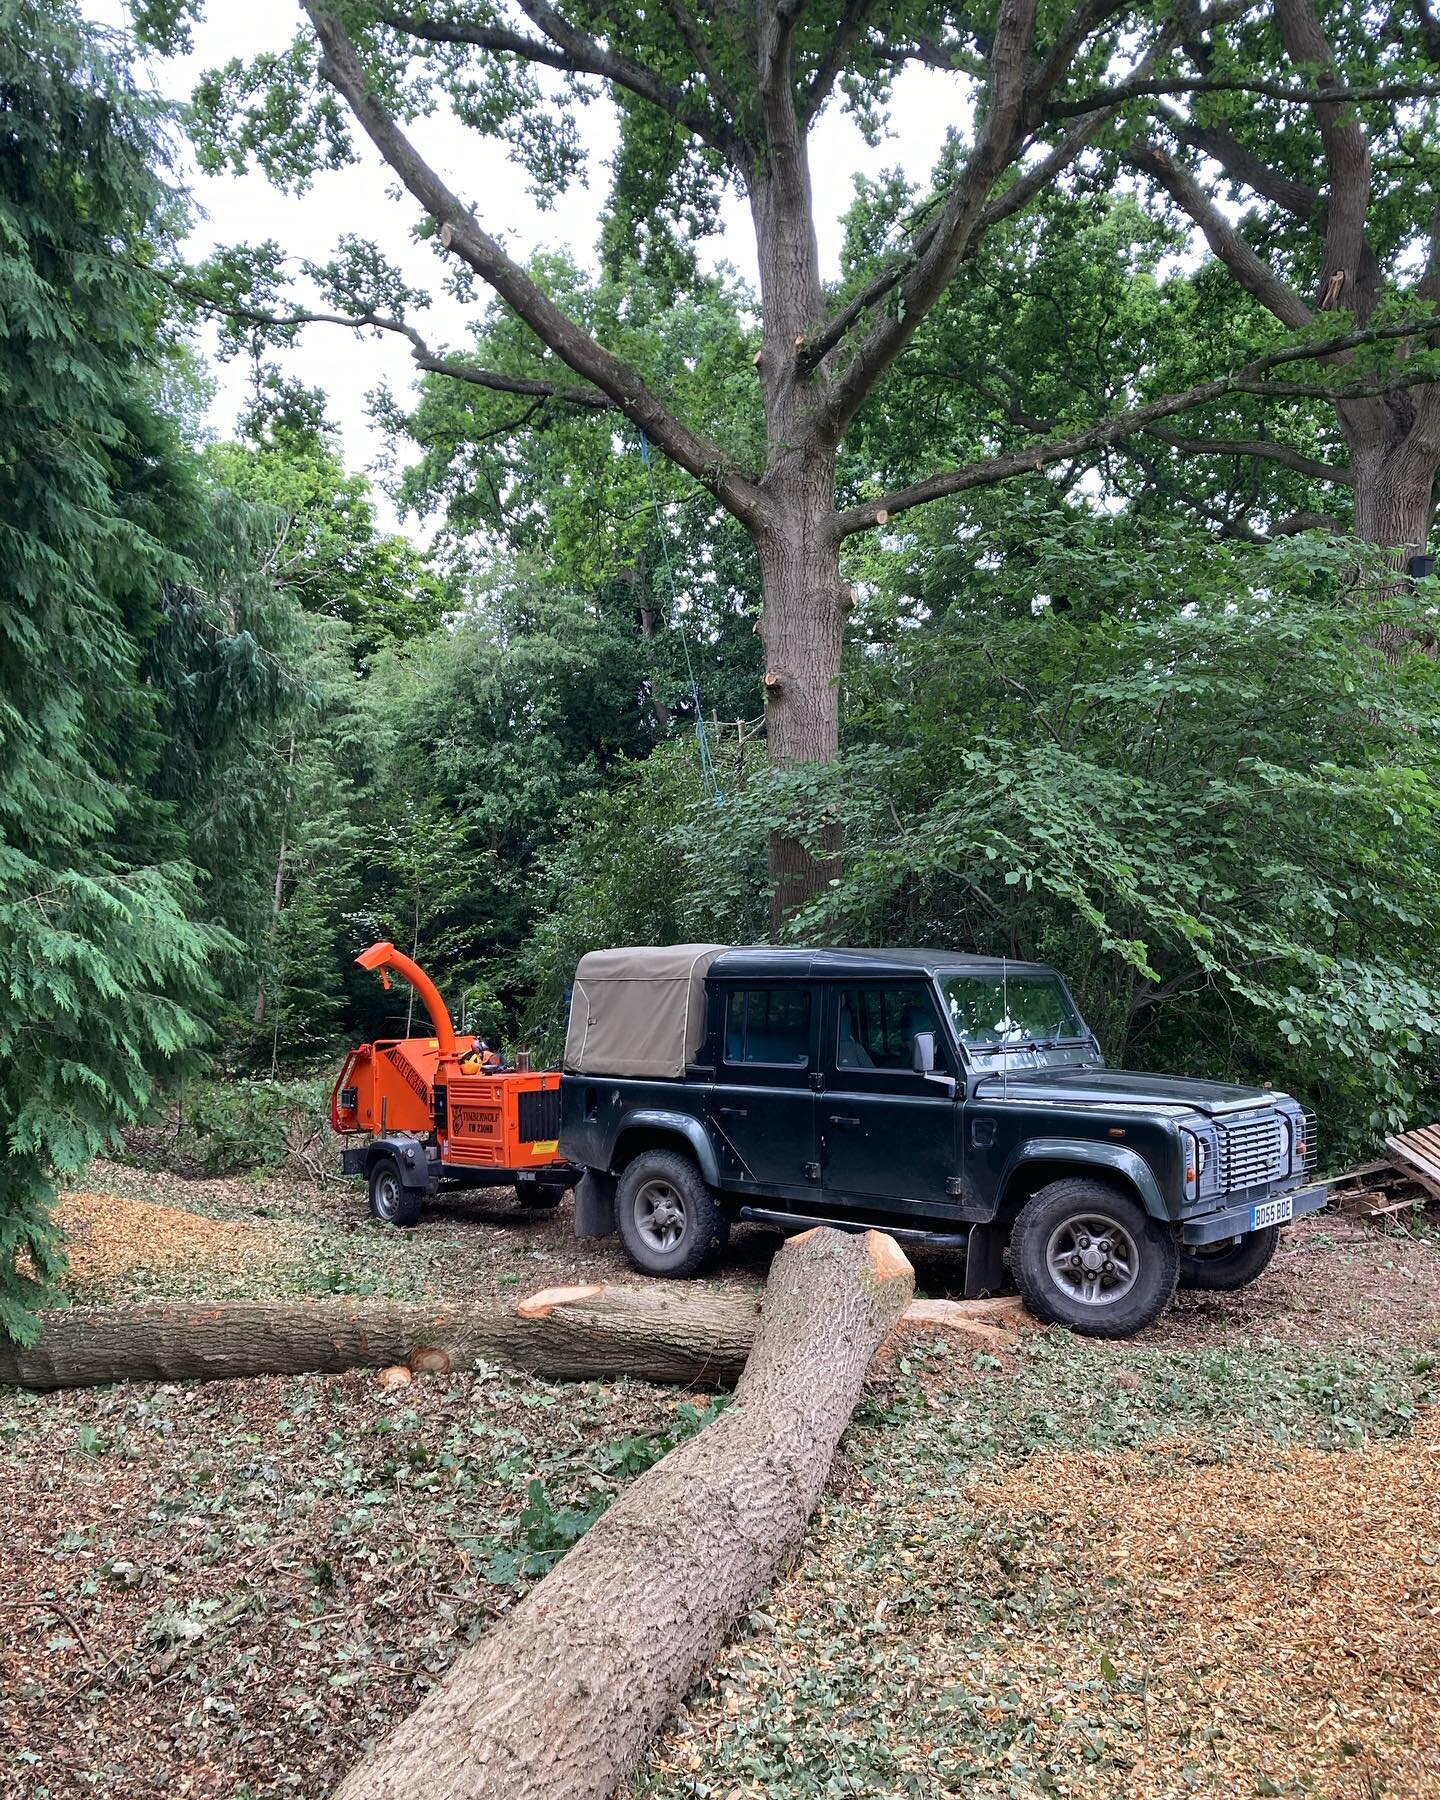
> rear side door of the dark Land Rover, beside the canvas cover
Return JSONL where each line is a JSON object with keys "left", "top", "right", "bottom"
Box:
{"left": 707, "top": 983, "right": 819, "bottom": 1195}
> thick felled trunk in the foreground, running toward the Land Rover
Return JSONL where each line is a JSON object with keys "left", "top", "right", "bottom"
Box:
{"left": 337, "top": 1228, "right": 914, "bottom": 1800}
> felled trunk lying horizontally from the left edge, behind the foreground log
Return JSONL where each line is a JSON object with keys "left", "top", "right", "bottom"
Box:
{"left": 0, "top": 1287, "right": 1022, "bottom": 1390}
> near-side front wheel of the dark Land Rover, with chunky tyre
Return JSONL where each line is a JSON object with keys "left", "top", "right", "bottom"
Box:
{"left": 1010, "top": 1175, "right": 1179, "bottom": 1337}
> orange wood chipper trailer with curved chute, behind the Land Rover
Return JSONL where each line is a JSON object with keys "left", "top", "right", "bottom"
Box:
{"left": 329, "top": 943, "right": 581, "bottom": 1226}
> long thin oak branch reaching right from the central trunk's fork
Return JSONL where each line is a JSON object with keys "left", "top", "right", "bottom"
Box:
{"left": 832, "top": 319, "right": 1435, "bottom": 538}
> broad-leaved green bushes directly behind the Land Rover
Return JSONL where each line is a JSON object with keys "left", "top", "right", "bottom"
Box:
{"left": 526, "top": 518, "right": 1440, "bottom": 1163}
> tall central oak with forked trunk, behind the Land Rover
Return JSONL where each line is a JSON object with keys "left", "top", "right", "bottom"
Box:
{"left": 157, "top": 0, "right": 1440, "bottom": 916}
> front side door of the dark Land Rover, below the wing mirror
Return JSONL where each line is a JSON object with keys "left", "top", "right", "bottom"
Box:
{"left": 817, "top": 981, "right": 959, "bottom": 1215}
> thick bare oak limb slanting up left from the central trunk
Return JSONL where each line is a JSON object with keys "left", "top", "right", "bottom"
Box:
{"left": 302, "top": 0, "right": 767, "bottom": 526}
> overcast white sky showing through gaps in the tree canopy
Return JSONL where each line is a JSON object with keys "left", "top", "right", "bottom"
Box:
{"left": 85, "top": 0, "right": 963, "bottom": 525}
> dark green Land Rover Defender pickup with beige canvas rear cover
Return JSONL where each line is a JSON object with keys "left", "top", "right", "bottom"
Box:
{"left": 560, "top": 943, "right": 1327, "bottom": 1337}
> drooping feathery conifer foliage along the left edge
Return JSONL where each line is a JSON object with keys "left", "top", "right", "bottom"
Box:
{"left": 0, "top": 4, "right": 227, "bottom": 1337}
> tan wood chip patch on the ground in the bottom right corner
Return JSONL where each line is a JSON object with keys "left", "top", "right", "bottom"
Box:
{"left": 972, "top": 1417, "right": 1440, "bottom": 1796}
